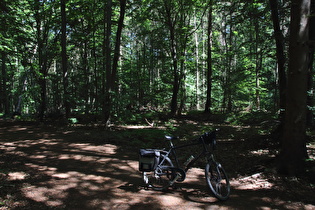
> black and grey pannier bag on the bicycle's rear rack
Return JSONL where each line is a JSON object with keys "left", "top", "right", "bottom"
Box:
{"left": 139, "top": 149, "right": 160, "bottom": 172}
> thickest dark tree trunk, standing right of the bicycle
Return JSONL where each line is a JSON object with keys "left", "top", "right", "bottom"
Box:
{"left": 278, "top": 0, "right": 310, "bottom": 175}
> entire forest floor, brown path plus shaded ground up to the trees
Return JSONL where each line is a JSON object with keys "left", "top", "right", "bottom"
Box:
{"left": 0, "top": 116, "right": 315, "bottom": 210}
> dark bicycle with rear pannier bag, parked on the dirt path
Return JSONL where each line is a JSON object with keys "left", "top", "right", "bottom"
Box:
{"left": 139, "top": 130, "right": 230, "bottom": 200}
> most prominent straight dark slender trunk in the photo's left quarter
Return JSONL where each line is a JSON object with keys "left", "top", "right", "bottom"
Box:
{"left": 60, "top": 0, "right": 70, "bottom": 119}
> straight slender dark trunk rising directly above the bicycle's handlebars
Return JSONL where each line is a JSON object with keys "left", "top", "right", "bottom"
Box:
{"left": 205, "top": 0, "right": 213, "bottom": 113}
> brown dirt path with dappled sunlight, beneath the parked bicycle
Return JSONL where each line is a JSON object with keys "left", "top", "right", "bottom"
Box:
{"left": 0, "top": 120, "right": 315, "bottom": 210}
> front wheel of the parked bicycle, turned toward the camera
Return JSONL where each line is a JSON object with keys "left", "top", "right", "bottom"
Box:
{"left": 205, "top": 161, "right": 231, "bottom": 201}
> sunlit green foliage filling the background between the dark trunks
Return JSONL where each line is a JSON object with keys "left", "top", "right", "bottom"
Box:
{"left": 0, "top": 0, "right": 294, "bottom": 124}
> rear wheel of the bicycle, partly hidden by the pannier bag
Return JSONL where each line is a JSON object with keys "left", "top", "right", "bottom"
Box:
{"left": 142, "top": 154, "right": 173, "bottom": 191}
